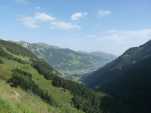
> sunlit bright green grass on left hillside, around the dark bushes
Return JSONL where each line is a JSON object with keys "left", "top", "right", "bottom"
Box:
{"left": 0, "top": 40, "right": 82, "bottom": 113}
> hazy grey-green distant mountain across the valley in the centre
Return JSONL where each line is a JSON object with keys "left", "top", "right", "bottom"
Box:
{"left": 20, "top": 42, "right": 115, "bottom": 79}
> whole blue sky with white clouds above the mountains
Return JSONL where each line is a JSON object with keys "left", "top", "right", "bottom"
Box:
{"left": 0, "top": 0, "right": 151, "bottom": 55}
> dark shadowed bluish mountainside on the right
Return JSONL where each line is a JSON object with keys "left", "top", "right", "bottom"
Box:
{"left": 84, "top": 41, "right": 151, "bottom": 113}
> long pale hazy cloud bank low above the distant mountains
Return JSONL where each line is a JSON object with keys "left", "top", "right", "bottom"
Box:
{"left": 50, "top": 28, "right": 151, "bottom": 55}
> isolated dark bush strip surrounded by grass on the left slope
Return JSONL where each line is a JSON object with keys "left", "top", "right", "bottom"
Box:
{"left": 8, "top": 69, "right": 56, "bottom": 105}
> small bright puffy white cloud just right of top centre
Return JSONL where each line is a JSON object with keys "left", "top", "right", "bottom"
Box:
{"left": 71, "top": 12, "right": 88, "bottom": 21}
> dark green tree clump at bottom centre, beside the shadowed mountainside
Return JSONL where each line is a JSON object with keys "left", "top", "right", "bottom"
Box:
{"left": 52, "top": 77, "right": 101, "bottom": 113}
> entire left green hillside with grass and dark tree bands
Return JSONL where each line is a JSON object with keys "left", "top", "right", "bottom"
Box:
{"left": 0, "top": 40, "right": 109, "bottom": 113}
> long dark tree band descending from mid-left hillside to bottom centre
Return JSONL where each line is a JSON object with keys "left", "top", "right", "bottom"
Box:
{"left": 33, "top": 58, "right": 102, "bottom": 113}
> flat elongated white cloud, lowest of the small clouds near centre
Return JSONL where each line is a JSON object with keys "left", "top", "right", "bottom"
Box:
{"left": 51, "top": 21, "right": 80, "bottom": 30}
